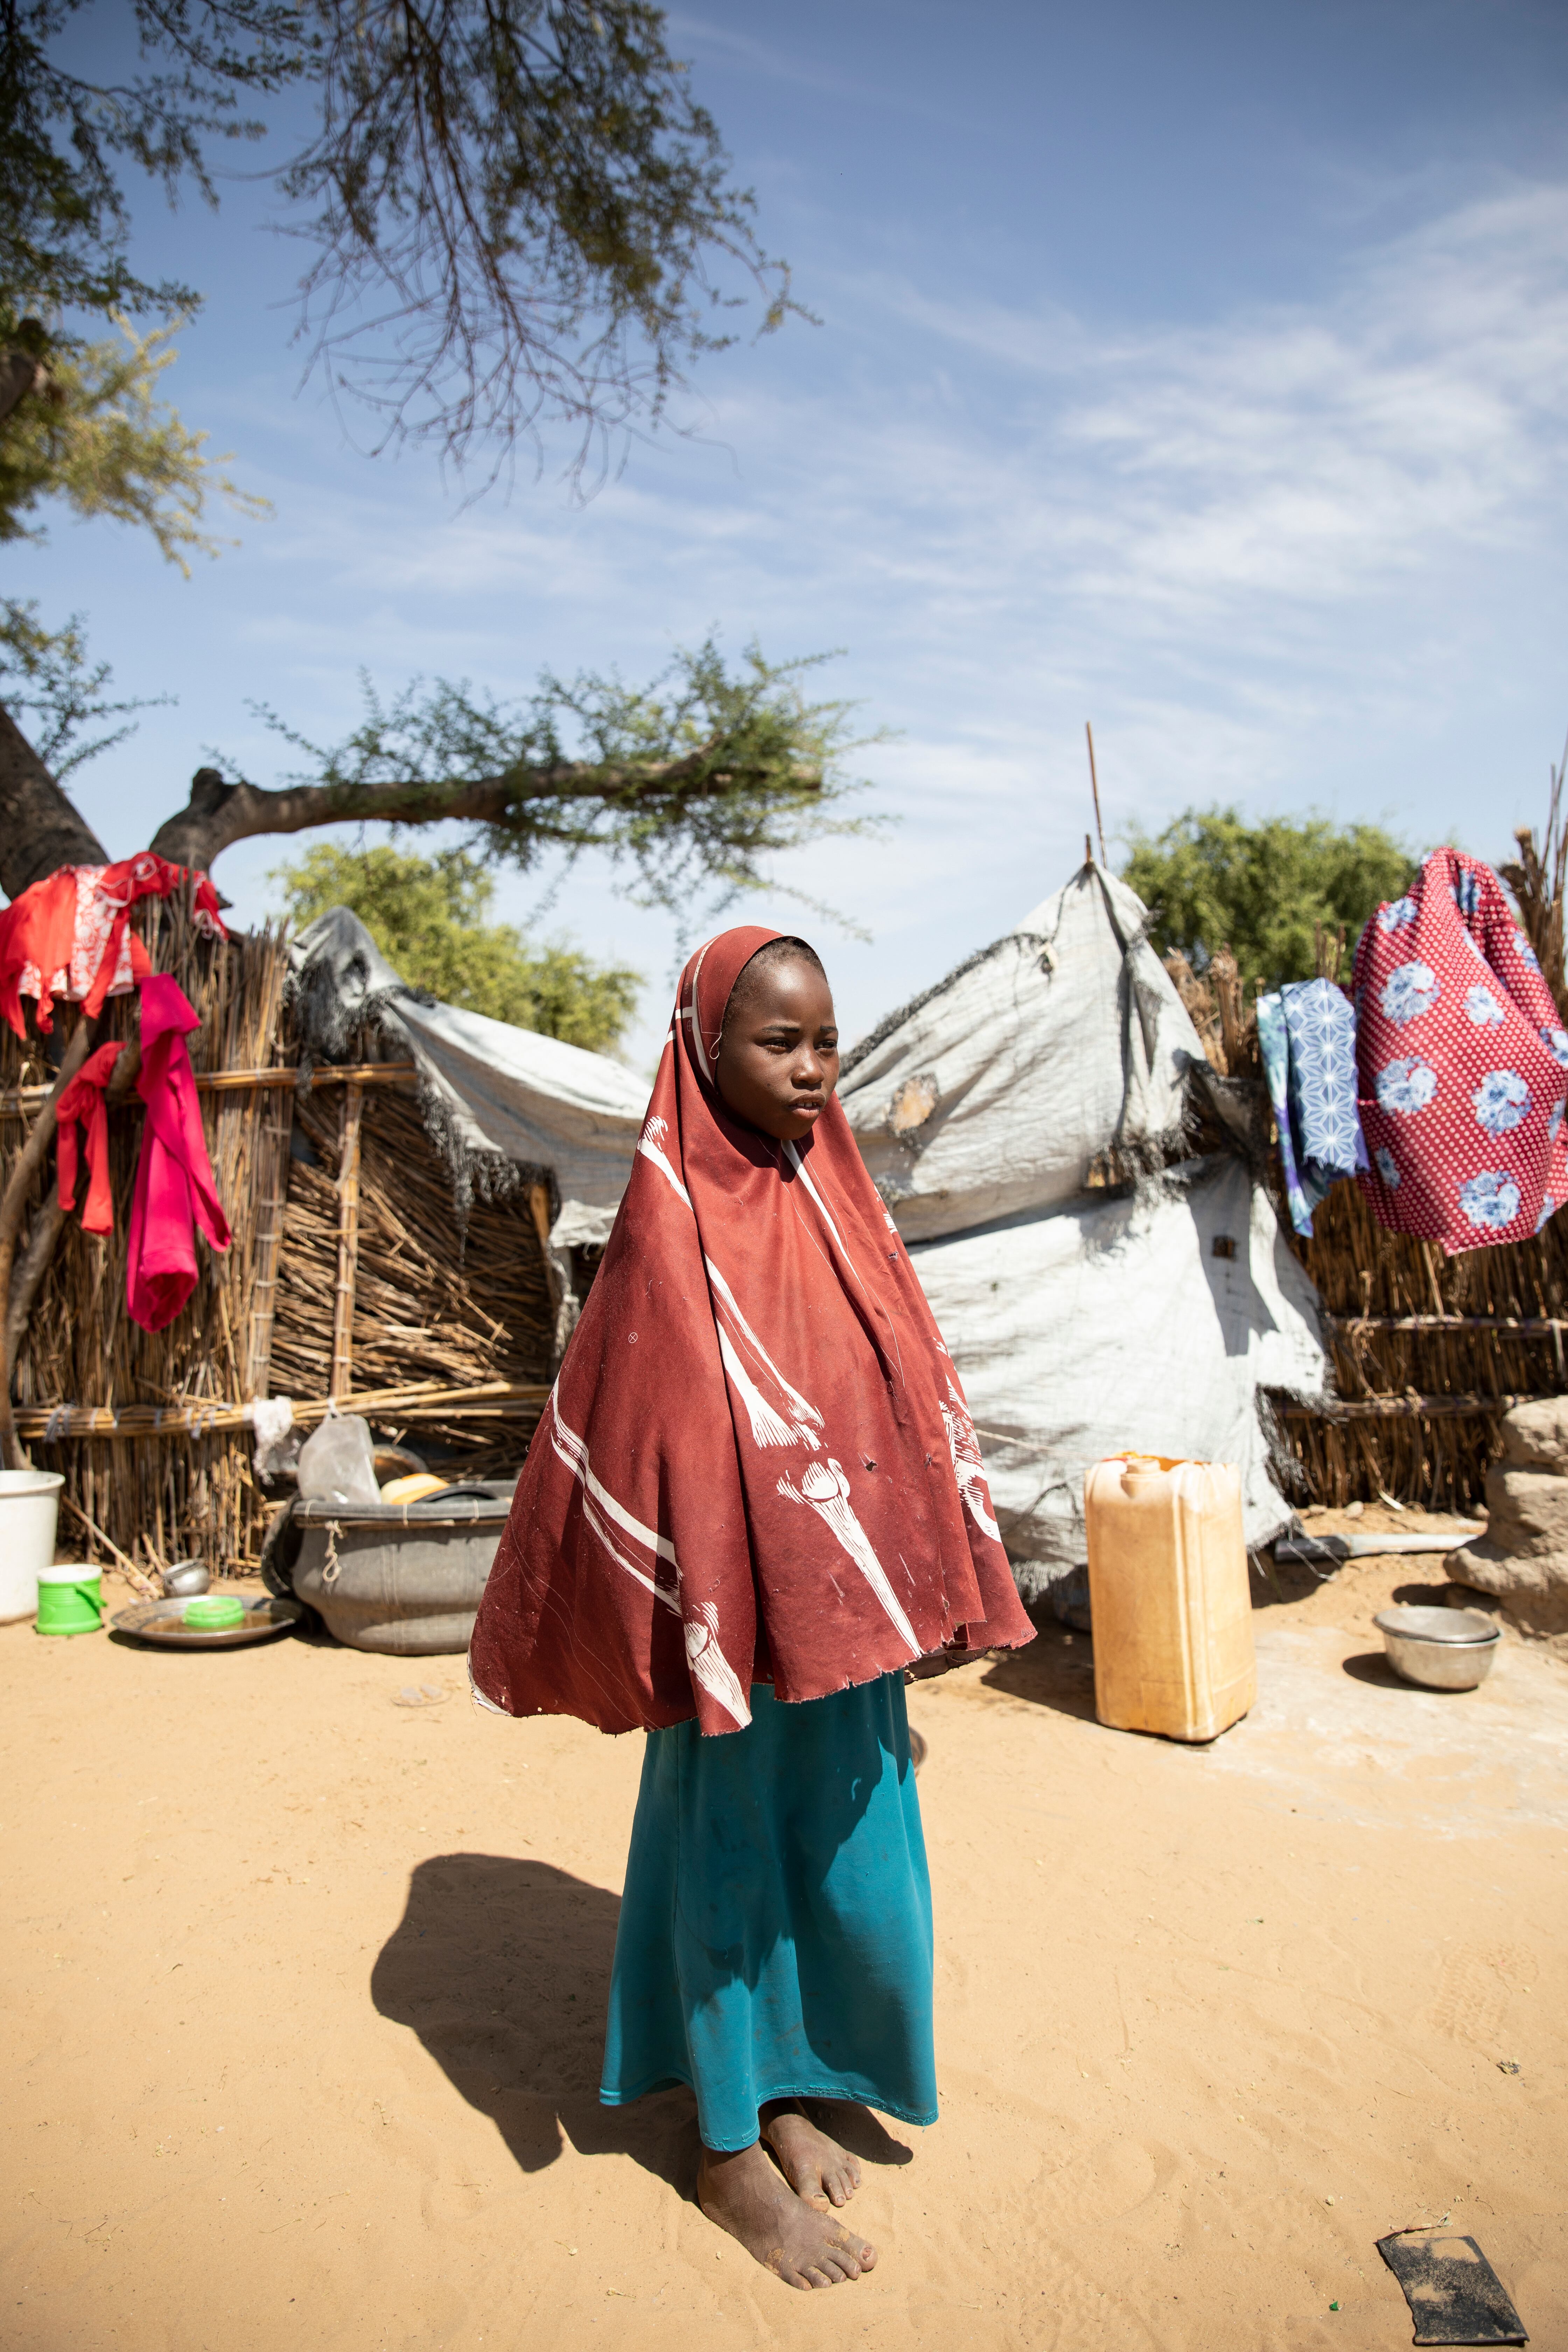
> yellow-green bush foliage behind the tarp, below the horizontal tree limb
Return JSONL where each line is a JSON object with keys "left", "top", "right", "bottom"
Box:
{"left": 270, "top": 842, "right": 642, "bottom": 1054}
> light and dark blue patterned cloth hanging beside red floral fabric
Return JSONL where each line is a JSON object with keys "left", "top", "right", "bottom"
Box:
{"left": 1258, "top": 964, "right": 1363, "bottom": 1237}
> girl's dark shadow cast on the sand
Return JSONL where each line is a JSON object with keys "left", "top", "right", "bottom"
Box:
{"left": 371, "top": 1853, "right": 910, "bottom": 2197}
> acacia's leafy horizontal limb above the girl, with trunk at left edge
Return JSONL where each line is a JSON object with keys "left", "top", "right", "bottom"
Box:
{"left": 0, "top": 640, "right": 867, "bottom": 915}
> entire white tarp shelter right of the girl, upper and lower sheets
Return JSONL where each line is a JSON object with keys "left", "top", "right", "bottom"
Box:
{"left": 839, "top": 866, "right": 1326, "bottom": 1597}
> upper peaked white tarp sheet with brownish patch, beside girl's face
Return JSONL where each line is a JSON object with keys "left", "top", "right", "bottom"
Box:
{"left": 839, "top": 866, "right": 1208, "bottom": 1242}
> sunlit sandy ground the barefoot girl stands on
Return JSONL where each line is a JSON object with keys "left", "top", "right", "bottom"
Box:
{"left": 0, "top": 1533, "right": 1568, "bottom": 2352}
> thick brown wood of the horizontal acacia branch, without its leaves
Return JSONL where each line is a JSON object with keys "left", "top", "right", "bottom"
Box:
{"left": 148, "top": 741, "right": 820, "bottom": 868}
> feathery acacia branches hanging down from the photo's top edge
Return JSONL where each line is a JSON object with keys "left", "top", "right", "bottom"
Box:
{"left": 0, "top": 0, "right": 794, "bottom": 479}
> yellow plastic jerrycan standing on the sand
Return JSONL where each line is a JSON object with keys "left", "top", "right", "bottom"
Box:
{"left": 1084, "top": 1454, "right": 1258, "bottom": 1741}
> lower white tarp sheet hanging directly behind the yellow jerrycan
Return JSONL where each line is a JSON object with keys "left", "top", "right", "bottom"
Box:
{"left": 910, "top": 1157, "right": 1326, "bottom": 1600}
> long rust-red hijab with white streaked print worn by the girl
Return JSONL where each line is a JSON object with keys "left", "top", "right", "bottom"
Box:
{"left": 470, "top": 927, "right": 1034, "bottom": 1731}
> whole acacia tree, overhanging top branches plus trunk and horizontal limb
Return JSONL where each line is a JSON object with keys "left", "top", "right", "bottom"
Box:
{"left": 0, "top": 0, "right": 842, "bottom": 903}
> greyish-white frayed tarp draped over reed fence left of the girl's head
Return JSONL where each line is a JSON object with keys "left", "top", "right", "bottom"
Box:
{"left": 292, "top": 905, "right": 649, "bottom": 1247}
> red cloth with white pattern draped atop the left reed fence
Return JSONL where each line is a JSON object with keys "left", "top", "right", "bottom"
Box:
{"left": 0, "top": 849, "right": 228, "bottom": 1037}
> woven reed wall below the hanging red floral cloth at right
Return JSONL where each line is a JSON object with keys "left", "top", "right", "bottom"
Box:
{"left": 1272, "top": 1181, "right": 1568, "bottom": 1512}
